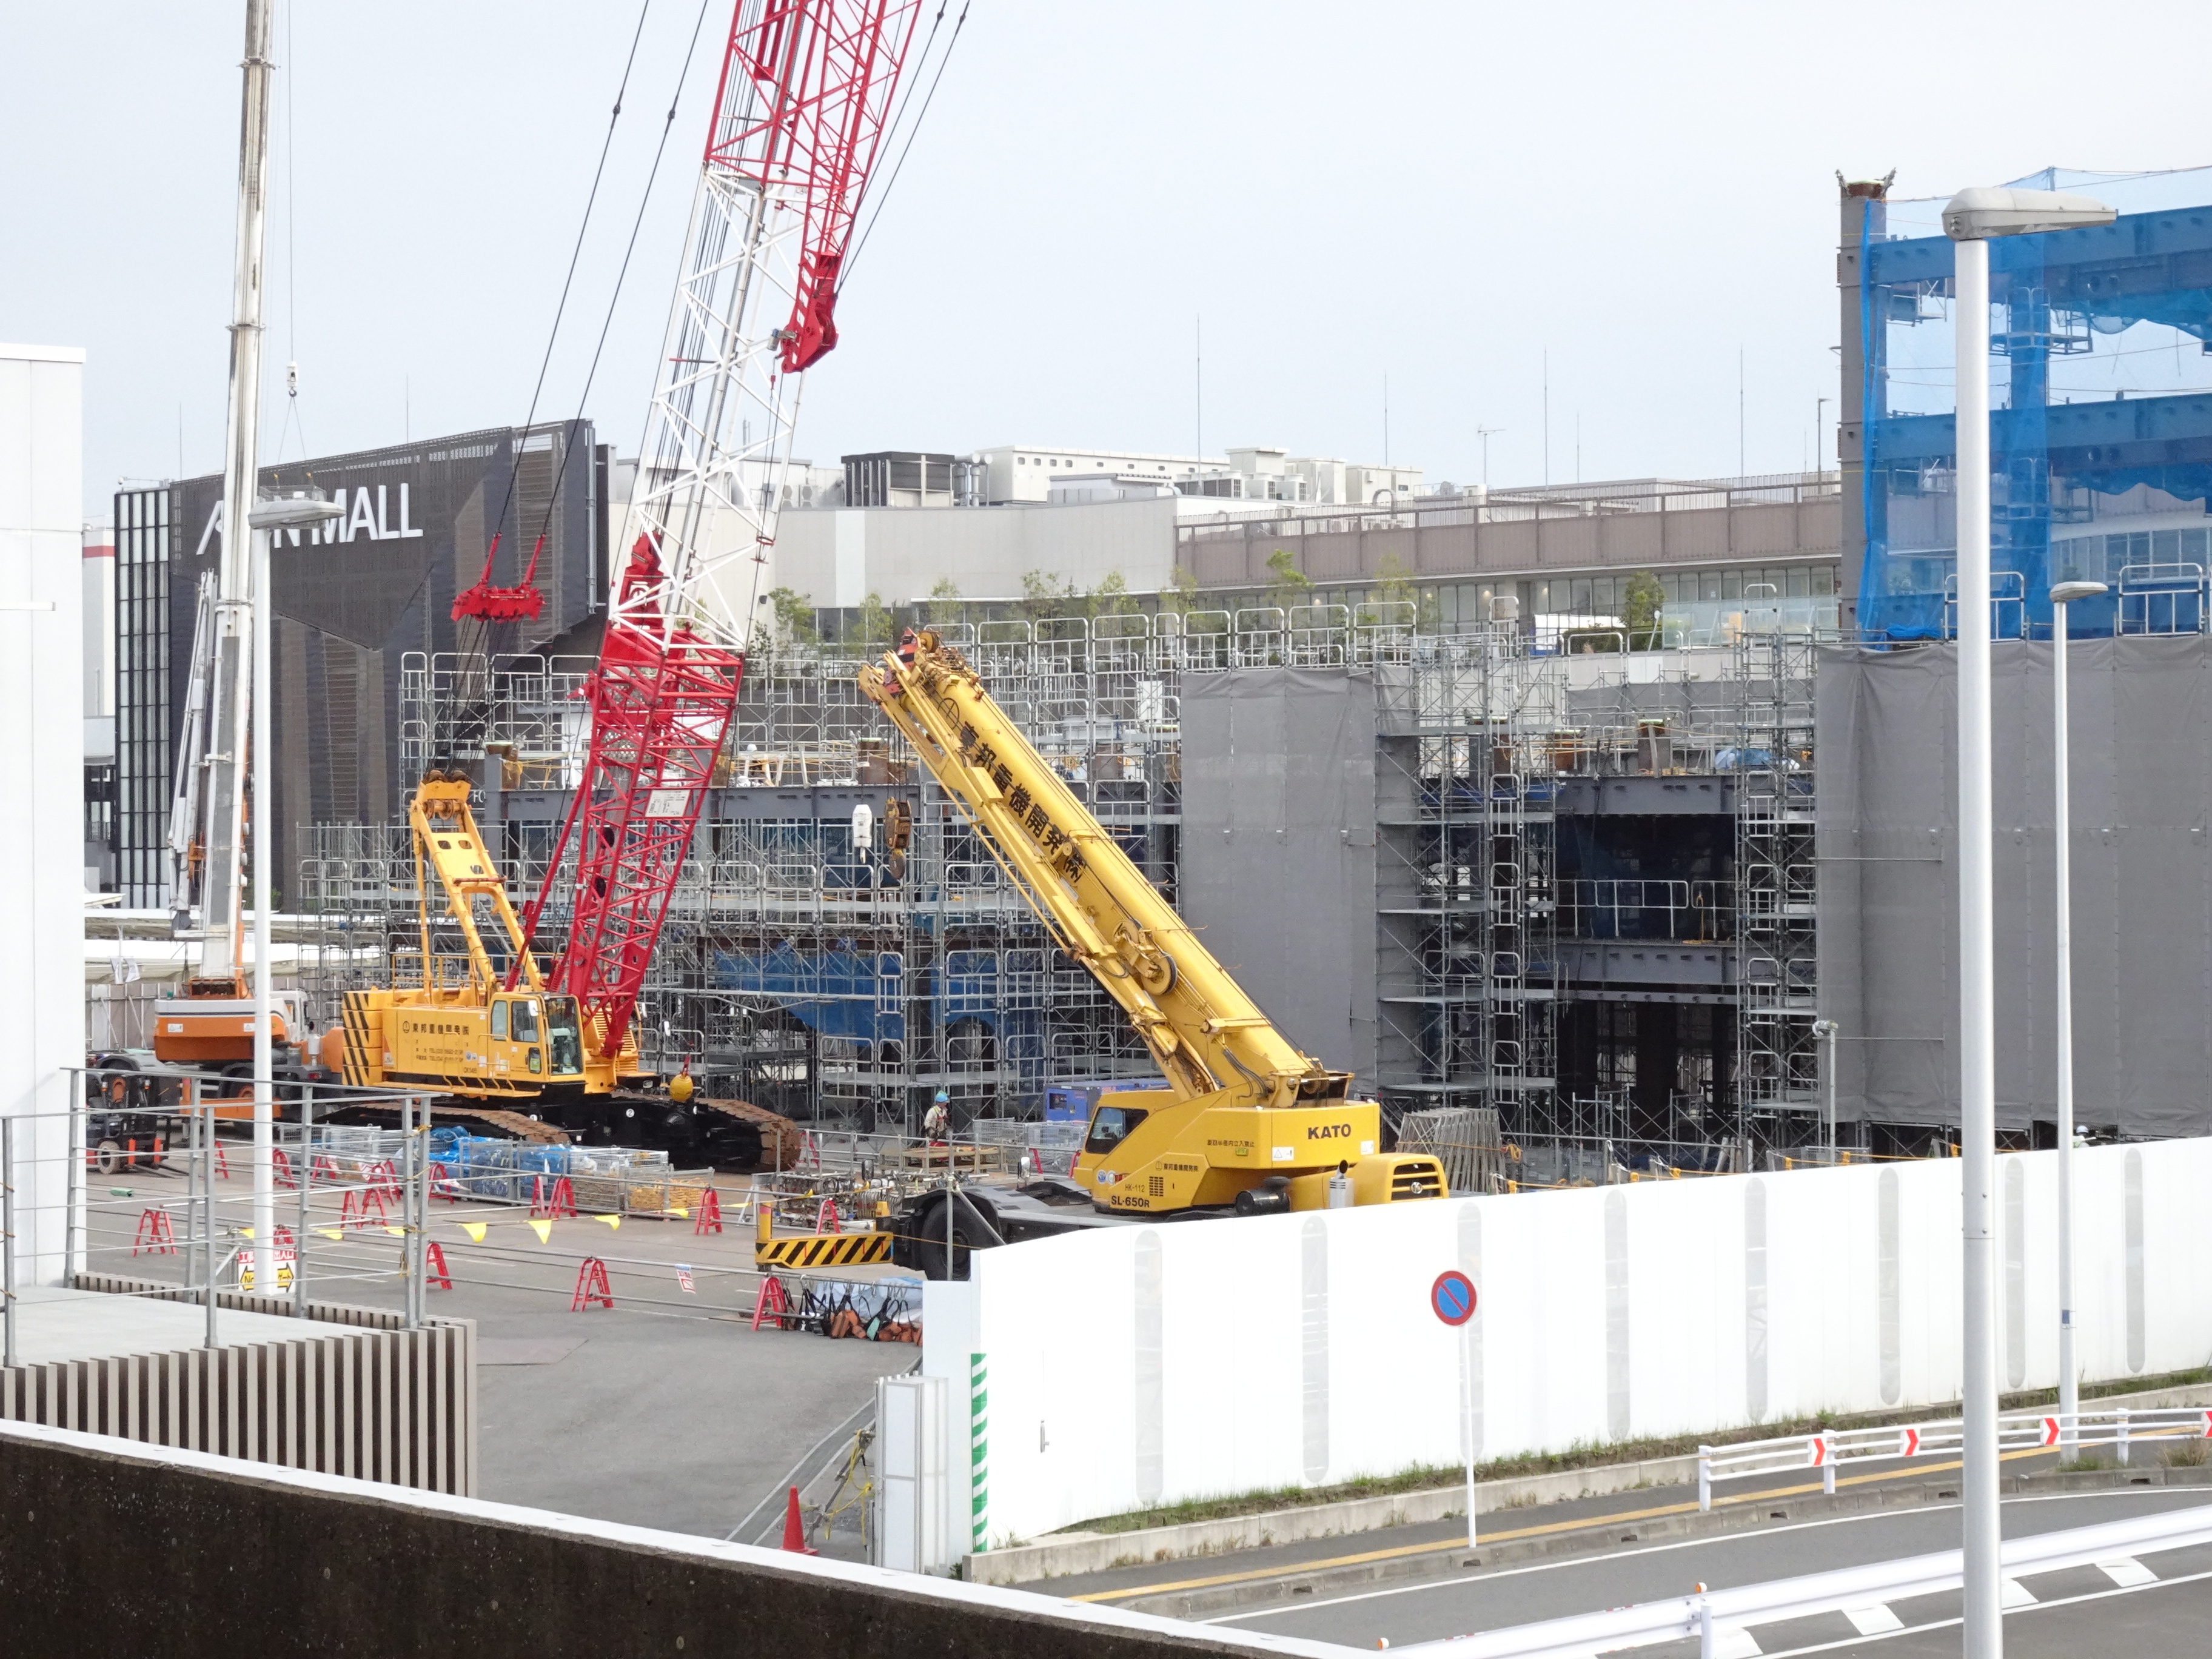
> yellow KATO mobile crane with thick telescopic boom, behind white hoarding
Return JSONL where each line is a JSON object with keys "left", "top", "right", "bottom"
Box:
{"left": 860, "top": 631, "right": 1444, "bottom": 1272}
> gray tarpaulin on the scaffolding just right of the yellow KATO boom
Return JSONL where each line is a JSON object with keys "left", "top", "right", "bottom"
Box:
{"left": 1181, "top": 668, "right": 1376, "bottom": 1084}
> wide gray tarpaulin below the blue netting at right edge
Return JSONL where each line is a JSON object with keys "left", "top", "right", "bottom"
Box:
{"left": 1818, "top": 635, "right": 2212, "bottom": 1134}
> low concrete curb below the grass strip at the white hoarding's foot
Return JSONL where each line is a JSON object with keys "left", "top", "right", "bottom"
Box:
{"left": 965, "top": 1382, "right": 2212, "bottom": 1584}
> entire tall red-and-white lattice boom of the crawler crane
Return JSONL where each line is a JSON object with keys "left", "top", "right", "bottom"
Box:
{"left": 529, "top": 0, "right": 920, "bottom": 1055}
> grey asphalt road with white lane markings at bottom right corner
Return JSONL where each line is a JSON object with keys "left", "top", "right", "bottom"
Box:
{"left": 1205, "top": 1486, "right": 2212, "bottom": 1659}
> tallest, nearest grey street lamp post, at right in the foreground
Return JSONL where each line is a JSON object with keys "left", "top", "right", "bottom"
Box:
{"left": 1942, "top": 188, "right": 2114, "bottom": 1659}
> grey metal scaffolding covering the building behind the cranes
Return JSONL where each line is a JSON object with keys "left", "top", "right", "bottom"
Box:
{"left": 276, "top": 597, "right": 1825, "bottom": 1179}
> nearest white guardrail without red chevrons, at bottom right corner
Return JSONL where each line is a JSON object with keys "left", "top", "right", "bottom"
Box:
{"left": 1404, "top": 1504, "right": 2212, "bottom": 1659}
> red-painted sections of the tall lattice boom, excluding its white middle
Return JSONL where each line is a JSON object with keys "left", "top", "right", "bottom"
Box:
{"left": 525, "top": 0, "right": 918, "bottom": 1055}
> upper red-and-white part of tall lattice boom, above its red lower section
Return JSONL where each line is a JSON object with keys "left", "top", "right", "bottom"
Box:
{"left": 615, "top": 0, "right": 920, "bottom": 648}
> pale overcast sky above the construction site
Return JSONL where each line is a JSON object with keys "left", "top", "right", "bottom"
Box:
{"left": 0, "top": 0, "right": 2212, "bottom": 520}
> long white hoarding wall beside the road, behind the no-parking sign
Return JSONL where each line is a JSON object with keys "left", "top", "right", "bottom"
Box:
{"left": 942, "top": 1139, "right": 2212, "bottom": 1544}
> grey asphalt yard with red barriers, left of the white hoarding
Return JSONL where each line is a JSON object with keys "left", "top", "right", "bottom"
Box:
{"left": 73, "top": 1148, "right": 920, "bottom": 1537}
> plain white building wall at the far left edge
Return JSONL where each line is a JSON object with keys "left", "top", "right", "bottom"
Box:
{"left": 0, "top": 345, "right": 84, "bottom": 1283}
